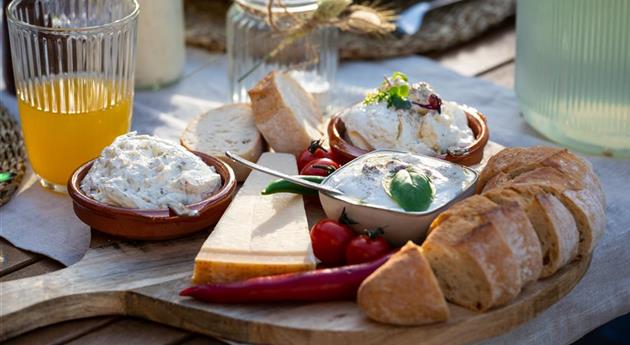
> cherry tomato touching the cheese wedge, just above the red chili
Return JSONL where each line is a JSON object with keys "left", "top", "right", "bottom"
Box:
{"left": 311, "top": 219, "right": 354, "bottom": 265}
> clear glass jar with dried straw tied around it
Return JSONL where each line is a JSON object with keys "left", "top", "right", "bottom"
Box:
{"left": 226, "top": 0, "right": 338, "bottom": 109}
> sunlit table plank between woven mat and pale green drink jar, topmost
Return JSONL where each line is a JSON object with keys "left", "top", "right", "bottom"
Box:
{"left": 429, "top": 20, "right": 516, "bottom": 76}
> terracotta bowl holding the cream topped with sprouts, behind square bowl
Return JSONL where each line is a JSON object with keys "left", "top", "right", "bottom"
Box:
{"left": 328, "top": 112, "right": 490, "bottom": 166}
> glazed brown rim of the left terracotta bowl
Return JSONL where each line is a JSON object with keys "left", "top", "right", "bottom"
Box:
{"left": 68, "top": 151, "right": 236, "bottom": 220}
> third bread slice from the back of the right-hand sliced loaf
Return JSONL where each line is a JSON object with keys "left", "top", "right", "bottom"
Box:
{"left": 483, "top": 185, "right": 579, "bottom": 277}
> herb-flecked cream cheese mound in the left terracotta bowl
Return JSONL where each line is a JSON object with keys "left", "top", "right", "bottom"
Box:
{"left": 81, "top": 132, "right": 221, "bottom": 209}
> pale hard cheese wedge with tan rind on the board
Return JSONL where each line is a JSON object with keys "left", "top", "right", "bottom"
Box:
{"left": 193, "top": 153, "right": 316, "bottom": 284}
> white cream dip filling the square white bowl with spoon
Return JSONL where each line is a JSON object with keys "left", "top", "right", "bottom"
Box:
{"left": 325, "top": 152, "right": 475, "bottom": 212}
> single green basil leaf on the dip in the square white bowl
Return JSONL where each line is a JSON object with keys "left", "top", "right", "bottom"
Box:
{"left": 383, "top": 167, "right": 435, "bottom": 212}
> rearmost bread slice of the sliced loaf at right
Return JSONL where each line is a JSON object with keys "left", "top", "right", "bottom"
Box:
{"left": 477, "top": 146, "right": 606, "bottom": 205}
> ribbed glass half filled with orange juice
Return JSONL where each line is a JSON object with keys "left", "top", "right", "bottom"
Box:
{"left": 7, "top": 0, "right": 139, "bottom": 192}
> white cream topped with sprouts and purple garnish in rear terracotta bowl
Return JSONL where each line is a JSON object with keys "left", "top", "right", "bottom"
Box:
{"left": 341, "top": 79, "right": 477, "bottom": 156}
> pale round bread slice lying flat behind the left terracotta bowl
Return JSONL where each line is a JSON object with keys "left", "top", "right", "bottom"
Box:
{"left": 180, "top": 104, "right": 265, "bottom": 181}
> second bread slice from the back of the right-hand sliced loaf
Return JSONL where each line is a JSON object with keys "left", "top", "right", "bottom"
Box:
{"left": 484, "top": 167, "right": 606, "bottom": 256}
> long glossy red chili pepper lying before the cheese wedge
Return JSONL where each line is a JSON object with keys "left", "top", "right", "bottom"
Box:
{"left": 179, "top": 254, "right": 391, "bottom": 303}
